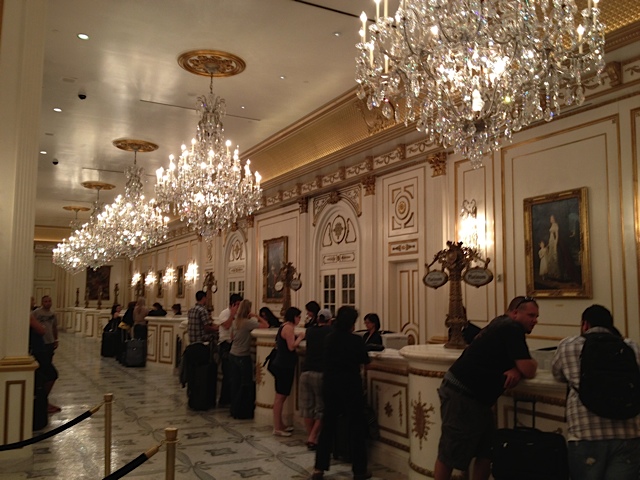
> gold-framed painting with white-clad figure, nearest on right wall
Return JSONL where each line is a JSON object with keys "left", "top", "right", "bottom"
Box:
{"left": 524, "top": 187, "right": 592, "bottom": 298}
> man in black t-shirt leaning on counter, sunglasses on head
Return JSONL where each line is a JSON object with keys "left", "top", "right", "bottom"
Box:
{"left": 434, "top": 297, "right": 538, "bottom": 480}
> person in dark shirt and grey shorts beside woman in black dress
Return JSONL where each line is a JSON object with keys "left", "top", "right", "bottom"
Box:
{"left": 299, "top": 308, "right": 333, "bottom": 450}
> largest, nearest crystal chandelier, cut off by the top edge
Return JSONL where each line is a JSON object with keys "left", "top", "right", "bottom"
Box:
{"left": 356, "top": 0, "right": 604, "bottom": 167}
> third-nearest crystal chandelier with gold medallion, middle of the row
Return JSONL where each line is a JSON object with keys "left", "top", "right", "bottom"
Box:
{"left": 98, "top": 138, "right": 169, "bottom": 259}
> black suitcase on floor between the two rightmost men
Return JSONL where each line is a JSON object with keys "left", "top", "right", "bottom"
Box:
{"left": 491, "top": 398, "right": 569, "bottom": 480}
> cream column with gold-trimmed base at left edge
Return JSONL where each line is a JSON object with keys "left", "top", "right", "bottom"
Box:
{"left": 0, "top": 0, "right": 47, "bottom": 466}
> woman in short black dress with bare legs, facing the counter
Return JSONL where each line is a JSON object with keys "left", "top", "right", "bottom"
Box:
{"left": 271, "top": 307, "right": 304, "bottom": 437}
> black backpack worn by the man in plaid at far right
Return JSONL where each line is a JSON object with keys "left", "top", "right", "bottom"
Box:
{"left": 578, "top": 332, "right": 640, "bottom": 420}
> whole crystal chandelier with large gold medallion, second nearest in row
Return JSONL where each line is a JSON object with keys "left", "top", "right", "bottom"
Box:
{"left": 156, "top": 50, "right": 262, "bottom": 238}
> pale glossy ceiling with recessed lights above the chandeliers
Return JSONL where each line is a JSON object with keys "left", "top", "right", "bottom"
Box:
{"left": 36, "top": 0, "right": 640, "bottom": 238}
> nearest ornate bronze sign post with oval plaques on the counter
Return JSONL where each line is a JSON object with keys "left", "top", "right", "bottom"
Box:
{"left": 422, "top": 241, "right": 493, "bottom": 348}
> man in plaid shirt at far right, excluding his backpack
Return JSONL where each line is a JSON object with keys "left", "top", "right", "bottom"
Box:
{"left": 552, "top": 305, "right": 640, "bottom": 480}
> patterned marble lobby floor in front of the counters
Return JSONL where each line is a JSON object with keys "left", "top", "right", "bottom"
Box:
{"left": 0, "top": 333, "right": 407, "bottom": 480}
